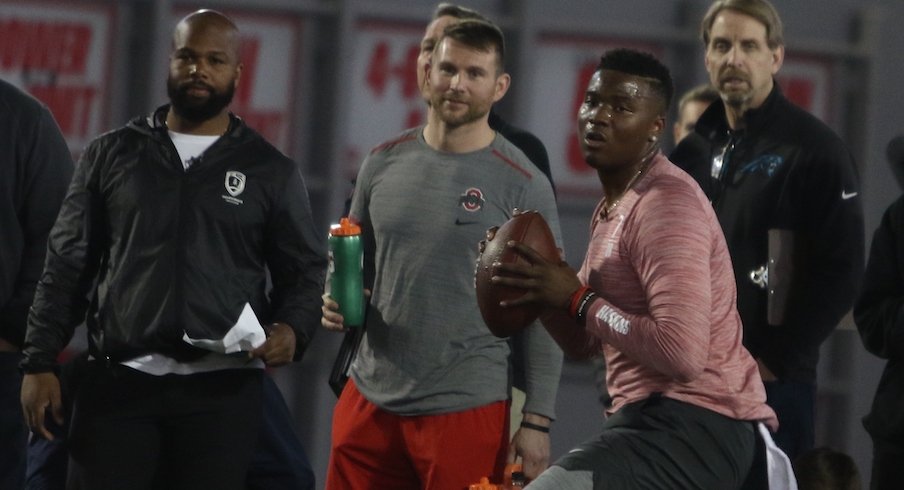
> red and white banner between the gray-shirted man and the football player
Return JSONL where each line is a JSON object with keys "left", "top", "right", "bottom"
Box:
{"left": 527, "top": 36, "right": 661, "bottom": 198}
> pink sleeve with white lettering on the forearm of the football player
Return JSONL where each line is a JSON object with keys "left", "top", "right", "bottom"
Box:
{"left": 586, "top": 186, "right": 716, "bottom": 382}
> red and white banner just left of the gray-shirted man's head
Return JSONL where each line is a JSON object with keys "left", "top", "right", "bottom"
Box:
{"left": 341, "top": 22, "right": 426, "bottom": 178}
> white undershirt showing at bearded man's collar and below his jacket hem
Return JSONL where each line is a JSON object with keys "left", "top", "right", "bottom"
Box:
{"left": 122, "top": 131, "right": 264, "bottom": 376}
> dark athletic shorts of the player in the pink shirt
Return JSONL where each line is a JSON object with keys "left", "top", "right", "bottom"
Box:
{"left": 555, "top": 395, "right": 756, "bottom": 490}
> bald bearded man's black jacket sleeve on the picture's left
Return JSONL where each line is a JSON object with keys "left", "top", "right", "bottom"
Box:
{"left": 22, "top": 141, "right": 104, "bottom": 372}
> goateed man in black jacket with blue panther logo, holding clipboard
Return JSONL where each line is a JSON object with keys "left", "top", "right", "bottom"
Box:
{"left": 671, "top": 0, "right": 864, "bottom": 459}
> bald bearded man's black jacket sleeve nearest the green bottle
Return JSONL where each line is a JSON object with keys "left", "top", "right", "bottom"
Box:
{"left": 266, "top": 164, "right": 327, "bottom": 360}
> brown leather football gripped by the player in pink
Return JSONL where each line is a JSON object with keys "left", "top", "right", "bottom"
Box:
{"left": 474, "top": 211, "right": 559, "bottom": 338}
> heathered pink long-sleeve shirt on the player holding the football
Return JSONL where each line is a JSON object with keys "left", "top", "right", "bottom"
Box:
{"left": 554, "top": 153, "right": 778, "bottom": 430}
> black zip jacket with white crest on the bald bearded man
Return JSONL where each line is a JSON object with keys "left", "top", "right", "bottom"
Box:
{"left": 22, "top": 106, "right": 326, "bottom": 372}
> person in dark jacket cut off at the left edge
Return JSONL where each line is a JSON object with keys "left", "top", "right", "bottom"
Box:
{"left": 0, "top": 80, "right": 72, "bottom": 488}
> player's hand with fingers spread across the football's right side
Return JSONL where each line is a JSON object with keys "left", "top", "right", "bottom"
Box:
{"left": 491, "top": 241, "right": 581, "bottom": 309}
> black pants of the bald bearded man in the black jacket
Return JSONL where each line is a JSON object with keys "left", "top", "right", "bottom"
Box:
{"left": 68, "top": 363, "right": 263, "bottom": 490}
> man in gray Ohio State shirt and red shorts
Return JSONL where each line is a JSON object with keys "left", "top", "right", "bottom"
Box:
{"left": 323, "top": 20, "right": 562, "bottom": 489}
